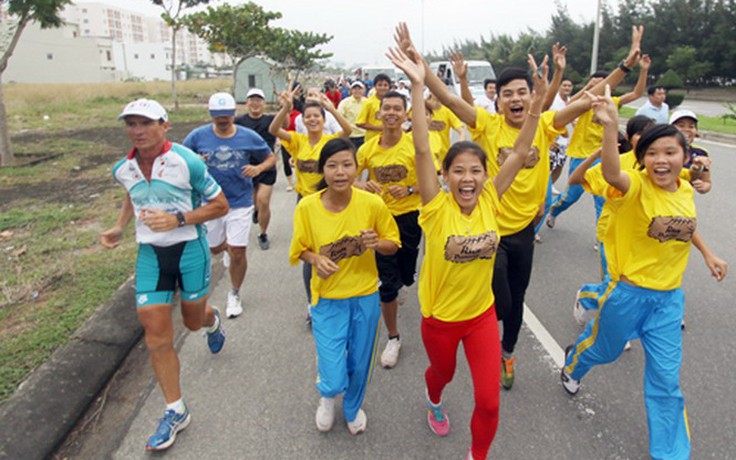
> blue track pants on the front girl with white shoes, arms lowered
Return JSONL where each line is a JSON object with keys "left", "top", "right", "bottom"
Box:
{"left": 311, "top": 292, "right": 381, "bottom": 421}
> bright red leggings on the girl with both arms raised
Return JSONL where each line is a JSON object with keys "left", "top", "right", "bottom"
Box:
{"left": 422, "top": 306, "right": 501, "bottom": 460}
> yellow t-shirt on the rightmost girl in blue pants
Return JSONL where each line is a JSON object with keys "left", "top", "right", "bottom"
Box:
{"left": 605, "top": 170, "right": 697, "bottom": 291}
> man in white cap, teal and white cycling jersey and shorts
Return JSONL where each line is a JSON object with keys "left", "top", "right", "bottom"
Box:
{"left": 100, "top": 99, "right": 228, "bottom": 450}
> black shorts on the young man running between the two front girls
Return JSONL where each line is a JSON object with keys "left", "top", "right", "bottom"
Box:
{"left": 376, "top": 211, "right": 422, "bottom": 302}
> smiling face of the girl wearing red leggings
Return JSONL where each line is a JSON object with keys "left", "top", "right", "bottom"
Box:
{"left": 442, "top": 150, "right": 488, "bottom": 214}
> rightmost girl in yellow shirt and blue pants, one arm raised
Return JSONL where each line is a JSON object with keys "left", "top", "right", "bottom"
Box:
{"left": 560, "top": 86, "right": 727, "bottom": 459}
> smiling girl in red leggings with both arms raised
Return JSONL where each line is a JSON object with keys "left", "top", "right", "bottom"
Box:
{"left": 391, "top": 45, "right": 548, "bottom": 459}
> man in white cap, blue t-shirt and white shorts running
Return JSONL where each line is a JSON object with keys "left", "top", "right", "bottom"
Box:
{"left": 184, "top": 93, "right": 276, "bottom": 318}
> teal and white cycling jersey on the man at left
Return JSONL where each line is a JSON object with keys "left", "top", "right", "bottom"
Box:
{"left": 112, "top": 142, "right": 222, "bottom": 246}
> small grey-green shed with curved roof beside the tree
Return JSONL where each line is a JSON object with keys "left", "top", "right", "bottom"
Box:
{"left": 234, "top": 56, "right": 287, "bottom": 103}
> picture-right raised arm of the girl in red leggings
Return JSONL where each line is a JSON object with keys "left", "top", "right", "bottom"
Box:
{"left": 493, "top": 54, "right": 549, "bottom": 199}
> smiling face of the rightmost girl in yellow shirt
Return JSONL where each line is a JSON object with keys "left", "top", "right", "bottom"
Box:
{"left": 643, "top": 136, "right": 685, "bottom": 192}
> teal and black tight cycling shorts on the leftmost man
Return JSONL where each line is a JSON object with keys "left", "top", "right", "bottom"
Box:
{"left": 135, "top": 237, "right": 210, "bottom": 307}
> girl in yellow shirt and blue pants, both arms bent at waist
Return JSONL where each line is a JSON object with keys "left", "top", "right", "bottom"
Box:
{"left": 289, "top": 139, "right": 400, "bottom": 434}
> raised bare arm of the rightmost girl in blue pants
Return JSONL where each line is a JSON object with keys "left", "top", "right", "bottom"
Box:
{"left": 590, "top": 86, "right": 631, "bottom": 194}
